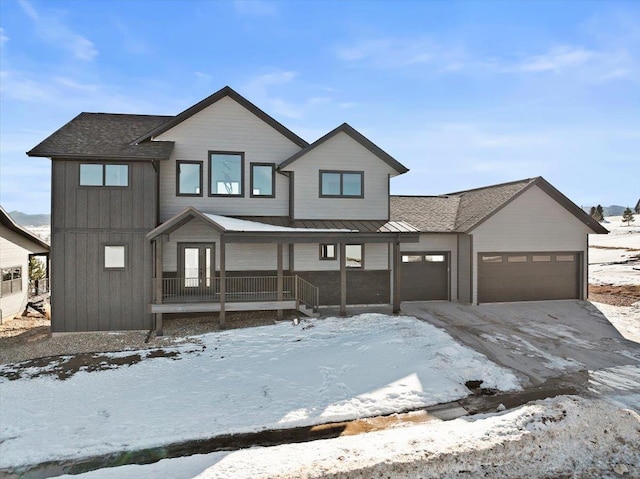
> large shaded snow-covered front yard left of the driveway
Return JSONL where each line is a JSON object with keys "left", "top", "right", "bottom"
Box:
{"left": 0, "top": 314, "right": 519, "bottom": 468}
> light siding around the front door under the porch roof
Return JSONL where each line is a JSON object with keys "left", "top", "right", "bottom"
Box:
{"left": 163, "top": 220, "right": 288, "bottom": 272}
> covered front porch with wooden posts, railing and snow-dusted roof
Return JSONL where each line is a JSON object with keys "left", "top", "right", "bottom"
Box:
{"left": 147, "top": 207, "right": 418, "bottom": 334}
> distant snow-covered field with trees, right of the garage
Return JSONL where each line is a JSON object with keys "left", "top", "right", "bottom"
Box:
{"left": 589, "top": 216, "right": 640, "bottom": 285}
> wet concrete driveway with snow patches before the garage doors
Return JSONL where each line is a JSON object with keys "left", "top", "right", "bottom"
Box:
{"left": 402, "top": 300, "right": 640, "bottom": 410}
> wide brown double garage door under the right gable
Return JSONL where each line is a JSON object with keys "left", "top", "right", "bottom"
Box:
{"left": 478, "top": 252, "right": 582, "bottom": 303}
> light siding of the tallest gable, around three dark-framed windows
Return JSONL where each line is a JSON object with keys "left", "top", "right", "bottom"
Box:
{"left": 155, "top": 97, "right": 300, "bottom": 221}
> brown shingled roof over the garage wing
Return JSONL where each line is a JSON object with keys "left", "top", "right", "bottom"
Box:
{"left": 390, "top": 176, "right": 608, "bottom": 233}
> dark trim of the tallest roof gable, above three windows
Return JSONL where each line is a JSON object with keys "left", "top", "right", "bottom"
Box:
{"left": 132, "top": 86, "right": 308, "bottom": 148}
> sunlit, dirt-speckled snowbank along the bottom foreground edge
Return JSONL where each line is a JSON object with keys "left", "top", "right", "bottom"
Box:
{"left": 55, "top": 396, "right": 640, "bottom": 479}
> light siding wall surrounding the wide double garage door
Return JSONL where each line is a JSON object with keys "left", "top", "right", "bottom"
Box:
{"left": 471, "top": 186, "right": 592, "bottom": 303}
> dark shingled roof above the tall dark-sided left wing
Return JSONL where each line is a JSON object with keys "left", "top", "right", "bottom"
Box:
{"left": 27, "top": 113, "right": 173, "bottom": 160}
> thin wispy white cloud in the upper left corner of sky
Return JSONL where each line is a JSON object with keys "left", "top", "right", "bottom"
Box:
{"left": 19, "top": 0, "right": 98, "bottom": 61}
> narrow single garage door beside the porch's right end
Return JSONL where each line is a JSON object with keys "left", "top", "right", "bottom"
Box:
{"left": 400, "top": 252, "right": 449, "bottom": 301}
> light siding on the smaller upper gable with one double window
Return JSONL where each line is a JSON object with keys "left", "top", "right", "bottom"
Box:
{"left": 285, "top": 132, "right": 397, "bottom": 220}
